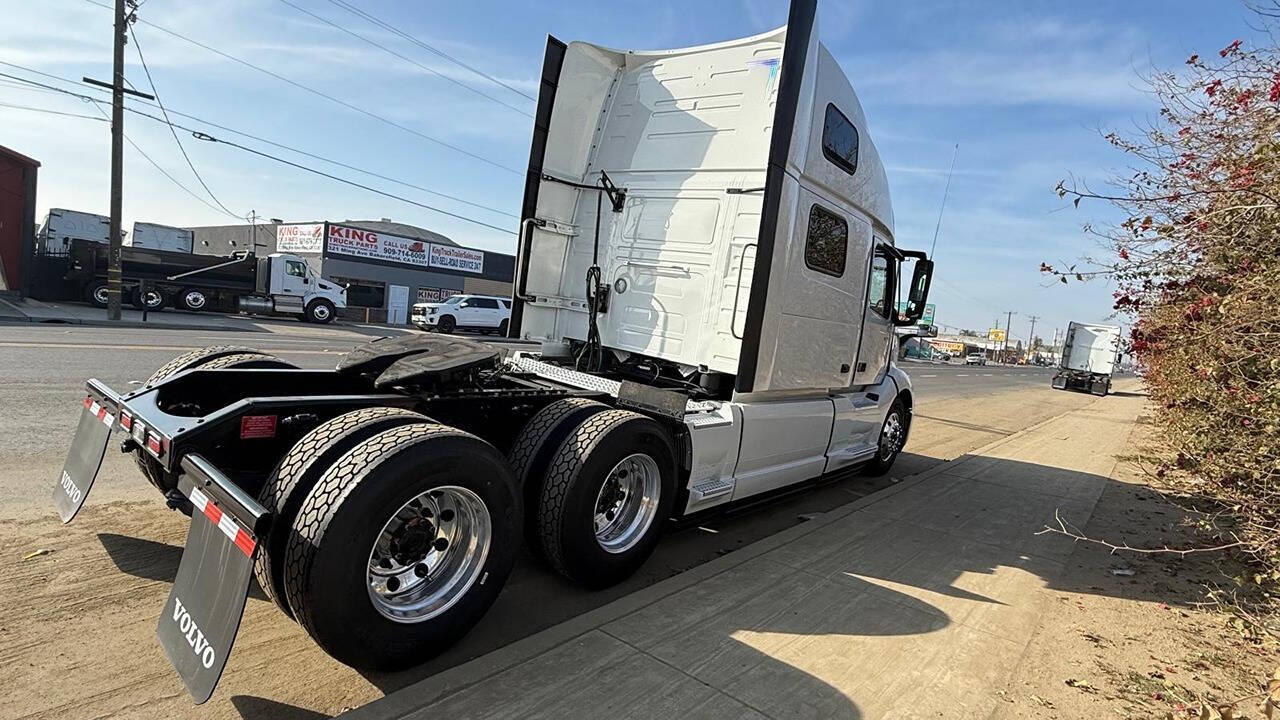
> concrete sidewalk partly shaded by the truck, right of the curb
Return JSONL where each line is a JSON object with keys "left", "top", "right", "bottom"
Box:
{"left": 343, "top": 380, "right": 1144, "bottom": 720}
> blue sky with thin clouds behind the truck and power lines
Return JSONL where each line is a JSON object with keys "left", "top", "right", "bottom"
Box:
{"left": 0, "top": 0, "right": 1252, "bottom": 338}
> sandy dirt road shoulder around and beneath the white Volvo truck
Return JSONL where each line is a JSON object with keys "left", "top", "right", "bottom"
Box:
{"left": 0, "top": 388, "right": 1092, "bottom": 720}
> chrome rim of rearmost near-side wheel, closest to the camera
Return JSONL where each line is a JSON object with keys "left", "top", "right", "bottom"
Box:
{"left": 366, "top": 486, "right": 493, "bottom": 623}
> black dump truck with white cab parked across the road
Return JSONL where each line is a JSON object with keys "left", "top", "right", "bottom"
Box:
{"left": 63, "top": 240, "right": 347, "bottom": 323}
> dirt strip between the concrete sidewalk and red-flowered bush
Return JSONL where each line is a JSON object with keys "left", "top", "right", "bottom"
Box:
{"left": 995, "top": 409, "right": 1280, "bottom": 720}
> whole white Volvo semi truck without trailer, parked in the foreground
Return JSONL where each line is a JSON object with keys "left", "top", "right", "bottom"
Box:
{"left": 54, "top": 0, "right": 932, "bottom": 702}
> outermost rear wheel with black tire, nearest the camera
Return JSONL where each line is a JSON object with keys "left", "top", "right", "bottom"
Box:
{"left": 283, "top": 424, "right": 521, "bottom": 670}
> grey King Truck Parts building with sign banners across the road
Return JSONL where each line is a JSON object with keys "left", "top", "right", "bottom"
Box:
{"left": 191, "top": 219, "right": 515, "bottom": 324}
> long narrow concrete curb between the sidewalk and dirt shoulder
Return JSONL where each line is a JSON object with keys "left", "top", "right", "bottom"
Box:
{"left": 338, "top": 398, "right": 1102, "bottom": 720}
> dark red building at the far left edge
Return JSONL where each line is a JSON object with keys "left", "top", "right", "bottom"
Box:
{"left": 0, "top": 146, "right": 40, "bottom": 295}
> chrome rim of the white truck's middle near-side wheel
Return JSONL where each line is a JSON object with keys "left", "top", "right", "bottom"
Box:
{"left": 594, "top": 452, "right": 662, "bottom": 553}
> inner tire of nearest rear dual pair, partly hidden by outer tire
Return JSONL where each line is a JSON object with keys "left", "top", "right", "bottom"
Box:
{"left": 253, "top": 407, "right": 430, "bottom": 618}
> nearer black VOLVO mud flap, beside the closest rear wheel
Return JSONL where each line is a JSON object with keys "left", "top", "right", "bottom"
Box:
{"left": 156, "top": 455, "right": 268, "bottom": 705}
